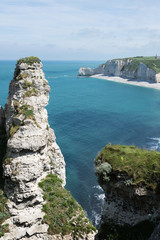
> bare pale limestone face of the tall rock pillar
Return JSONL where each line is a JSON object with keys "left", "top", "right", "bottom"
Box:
{"left": 2, "top": 60, "right": 65, "bottom": 240}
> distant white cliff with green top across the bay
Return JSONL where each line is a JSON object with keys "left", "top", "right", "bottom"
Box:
{"left": 78, "top": 57, "right": 160, "bottom": 83}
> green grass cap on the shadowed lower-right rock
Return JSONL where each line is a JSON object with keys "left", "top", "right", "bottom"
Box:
{"left": 95, "top": 144, "right": 160, "bottom": 191}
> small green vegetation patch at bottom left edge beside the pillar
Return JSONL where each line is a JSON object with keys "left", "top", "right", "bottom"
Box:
{"left": 0, "top": 190, "right": 10, "bottom": 237}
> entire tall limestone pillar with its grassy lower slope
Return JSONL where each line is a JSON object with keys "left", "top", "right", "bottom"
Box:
{"left": 0, "top": 57, "right": 95, "bottom": 240}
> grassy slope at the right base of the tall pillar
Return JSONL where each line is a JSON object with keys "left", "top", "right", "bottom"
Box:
{"left": 39, "top": 174, "right": 96, "bottom": 239}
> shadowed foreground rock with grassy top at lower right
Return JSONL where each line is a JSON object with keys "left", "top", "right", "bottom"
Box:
{"left": 95, "top": 145, "right": 160, "bottom": 240}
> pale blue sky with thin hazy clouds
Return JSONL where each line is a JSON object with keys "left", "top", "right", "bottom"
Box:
{"left": 0, "top": 0, "right": 160, "bottom": 60}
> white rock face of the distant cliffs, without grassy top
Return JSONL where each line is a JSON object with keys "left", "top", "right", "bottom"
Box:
{"left": 78, "top": 59, "right": 160, "bottom": 82}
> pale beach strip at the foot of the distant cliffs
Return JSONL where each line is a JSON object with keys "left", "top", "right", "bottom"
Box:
{"left": 90, "top": 74, "right": 160, "bottom": 90}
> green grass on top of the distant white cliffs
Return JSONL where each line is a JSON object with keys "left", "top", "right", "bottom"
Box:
{"left": 114, "top": 56, "right": 160, "bottom": 73}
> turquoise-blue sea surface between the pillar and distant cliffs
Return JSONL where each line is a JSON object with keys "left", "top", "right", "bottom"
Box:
{"left": 0, "top": 61, "right": 160, "bottom": 224}
